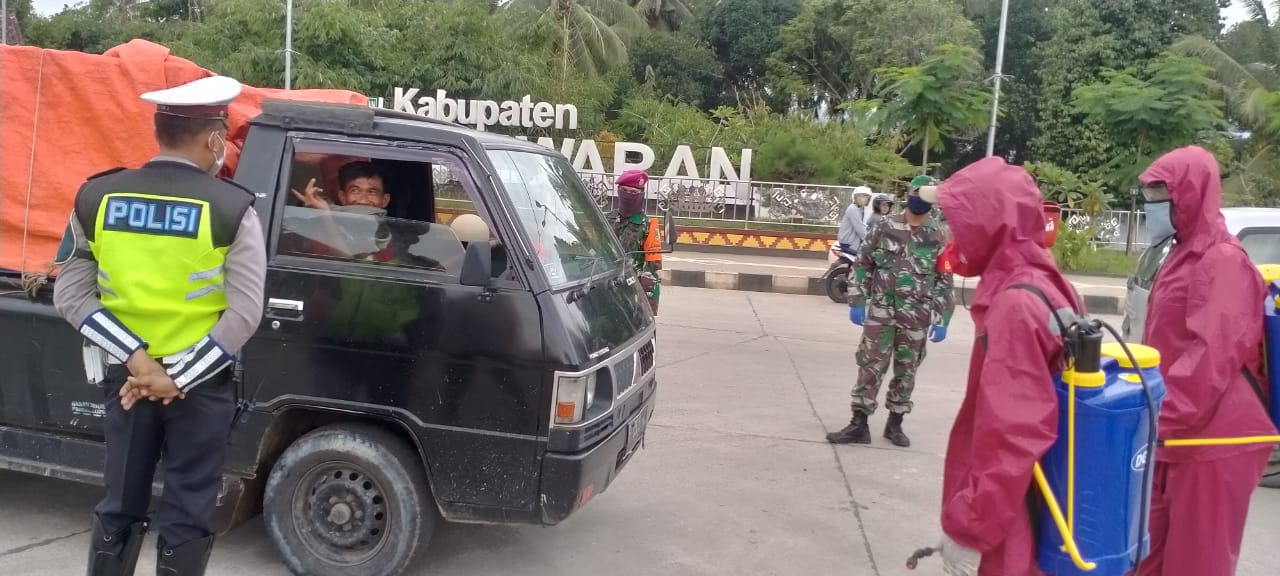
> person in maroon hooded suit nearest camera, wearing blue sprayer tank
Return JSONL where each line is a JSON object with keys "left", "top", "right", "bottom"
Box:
{"left": 920, "top": 156, "right": 1084, "bottom": 576}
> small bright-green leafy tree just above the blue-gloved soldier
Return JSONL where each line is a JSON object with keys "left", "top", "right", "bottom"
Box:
{"left": 877, "top": 44, "right": 991, "bottom": 173}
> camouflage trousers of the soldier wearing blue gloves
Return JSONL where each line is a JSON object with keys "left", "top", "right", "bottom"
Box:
{"left": 851, "top": 314, "right": 929, "bottom": 416}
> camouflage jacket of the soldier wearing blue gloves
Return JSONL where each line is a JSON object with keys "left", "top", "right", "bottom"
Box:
{"left": 849, "top": 214, "right": 955, "bottom": 326}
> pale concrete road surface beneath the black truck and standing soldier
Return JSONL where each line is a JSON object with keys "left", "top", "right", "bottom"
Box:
{"left": 0, "top": 287, "right": 1280, "bottom": 576}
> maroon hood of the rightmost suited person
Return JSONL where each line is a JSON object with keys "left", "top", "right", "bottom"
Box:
{"left": 1138, "top": 146, "right": 1231, "bottom": 252}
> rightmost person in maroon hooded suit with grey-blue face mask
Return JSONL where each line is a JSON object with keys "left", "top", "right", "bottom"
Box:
{"left": 1138, "top": 146, "right": 1276, "bottom": 576}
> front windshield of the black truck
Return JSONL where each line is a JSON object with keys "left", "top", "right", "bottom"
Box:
{"left": 489, "top": 150, "right": 622, "bottom": 288}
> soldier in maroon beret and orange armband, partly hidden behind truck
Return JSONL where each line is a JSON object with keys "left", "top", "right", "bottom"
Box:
{"left": 609, "top": 170, "right": 662, "bottom": 316}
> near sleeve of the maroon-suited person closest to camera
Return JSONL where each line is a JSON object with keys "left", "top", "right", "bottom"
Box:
{"left": 942, "top": 291, "right": 1061, "bottom": 553}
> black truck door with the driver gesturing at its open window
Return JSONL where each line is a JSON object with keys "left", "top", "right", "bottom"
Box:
{"left": 243, "top": 138, "right": 545, "bottom": 509}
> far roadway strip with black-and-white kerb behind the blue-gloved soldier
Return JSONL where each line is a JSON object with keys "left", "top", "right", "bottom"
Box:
{"left": 662, "top": 250, "right": 1125, "bottom": 314}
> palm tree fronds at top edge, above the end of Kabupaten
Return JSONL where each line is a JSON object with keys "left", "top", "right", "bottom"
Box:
{"left": 507, "top": 0, "right": 648, "bottom": 78}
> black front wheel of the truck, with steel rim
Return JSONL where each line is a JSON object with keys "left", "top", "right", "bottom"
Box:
{"left": 262, "top": 425, "right": 436, "bottom": 576}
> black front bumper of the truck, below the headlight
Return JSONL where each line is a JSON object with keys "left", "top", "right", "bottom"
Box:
{"left": 541, "top": 381, "right": 657, "bottom": 526}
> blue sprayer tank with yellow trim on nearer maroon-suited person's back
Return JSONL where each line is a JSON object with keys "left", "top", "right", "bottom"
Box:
{"left": 1033, "top": 343, "right": 1165, "bottom": 576}
